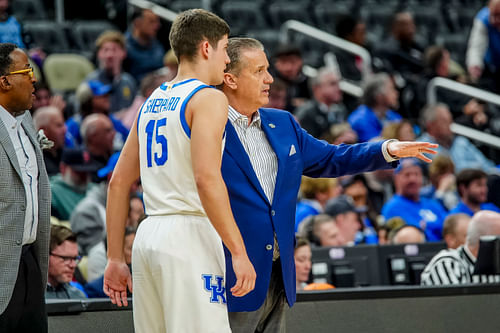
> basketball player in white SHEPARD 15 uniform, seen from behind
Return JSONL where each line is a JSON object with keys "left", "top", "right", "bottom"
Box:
{"left": 104, "top": 9, "right": 256, "bottom": 333}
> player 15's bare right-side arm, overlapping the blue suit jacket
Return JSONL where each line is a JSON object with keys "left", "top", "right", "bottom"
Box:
{"left": 186, "top": 89, "right": 256, "bottom": 296}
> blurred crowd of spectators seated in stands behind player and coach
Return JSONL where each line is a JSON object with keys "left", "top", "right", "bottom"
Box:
{"left": 0, "top": 1, "right": 500, "bottom": 298}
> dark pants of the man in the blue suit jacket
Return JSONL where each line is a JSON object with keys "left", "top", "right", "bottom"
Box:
{"left": 229, "top": 260, "right": 288, "bottom": 333}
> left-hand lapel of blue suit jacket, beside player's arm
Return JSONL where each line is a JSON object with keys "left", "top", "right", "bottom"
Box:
{"left": 225, "top": 121, "right": 269, "bottom": 202}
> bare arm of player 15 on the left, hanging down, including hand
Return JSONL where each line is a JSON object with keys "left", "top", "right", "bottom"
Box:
{"left": 103, "top": 113, "right": 140, "bottom": 306}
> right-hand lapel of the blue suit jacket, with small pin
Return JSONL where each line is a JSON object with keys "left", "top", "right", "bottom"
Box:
{"left": 259, "top": 109, "right": 290, "bottom": 202}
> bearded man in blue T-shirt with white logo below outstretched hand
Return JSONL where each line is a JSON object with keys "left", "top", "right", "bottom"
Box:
{"left": 382, "top": 158, "right": 446, "bottom": 241}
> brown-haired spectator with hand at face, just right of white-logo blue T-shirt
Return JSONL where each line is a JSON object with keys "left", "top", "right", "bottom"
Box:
{"left": 420, "top": 155, "right": 459, "bottom": 211}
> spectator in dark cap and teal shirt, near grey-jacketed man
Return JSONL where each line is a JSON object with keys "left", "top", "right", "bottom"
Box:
{"left": 50, "top": 148, "right": 99, "bottom": 221}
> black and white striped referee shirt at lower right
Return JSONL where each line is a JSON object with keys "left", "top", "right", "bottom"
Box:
{"left": 421, "top": 245, "right": 500, "bottom": 286}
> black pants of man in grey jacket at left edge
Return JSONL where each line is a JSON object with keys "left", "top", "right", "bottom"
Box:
{"left": 0, "top": 246, "right": 48, "bottom": 333}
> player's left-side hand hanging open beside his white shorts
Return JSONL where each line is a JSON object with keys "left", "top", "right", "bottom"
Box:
{"left": 103, "top": 259, "right": 132, "bottom": 306}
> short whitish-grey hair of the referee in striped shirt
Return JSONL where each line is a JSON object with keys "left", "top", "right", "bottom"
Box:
{"left": 465, "top": 210, "right": 500, "bottom": 247}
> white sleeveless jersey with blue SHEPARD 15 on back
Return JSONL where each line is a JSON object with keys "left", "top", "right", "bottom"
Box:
{"left": 137, "top": 79, "right": 215, "bottom": 216}
